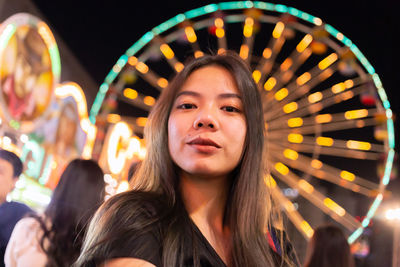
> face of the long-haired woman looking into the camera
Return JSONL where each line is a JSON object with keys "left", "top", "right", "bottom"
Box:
{"left": 168, "top": 66, "right": 246, "bottom": 180}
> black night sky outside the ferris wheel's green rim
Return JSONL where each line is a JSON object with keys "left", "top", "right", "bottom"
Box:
{"left": 33, "top": 0, "right": 400, "bottom": 146}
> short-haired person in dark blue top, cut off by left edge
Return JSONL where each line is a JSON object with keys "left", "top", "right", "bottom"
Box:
{"left": 0, "top": 149, "right": 32, "bottom": 267}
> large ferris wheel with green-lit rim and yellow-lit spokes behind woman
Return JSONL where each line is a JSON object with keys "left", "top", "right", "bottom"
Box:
{"left": 90, "top": 1, "right": 394, "bottom": 243}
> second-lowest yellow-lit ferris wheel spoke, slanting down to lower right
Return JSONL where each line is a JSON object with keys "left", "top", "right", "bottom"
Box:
{"left": 271, "top": 162, "right": 361, "bottom": 231}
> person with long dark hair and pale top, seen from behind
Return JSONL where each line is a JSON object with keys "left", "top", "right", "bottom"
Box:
{"left": 4, "top": 159, "right": 105, "bottom": 267}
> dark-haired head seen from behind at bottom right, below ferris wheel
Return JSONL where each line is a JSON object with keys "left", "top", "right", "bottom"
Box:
{"left": 304, "top": 224, "right": 355, "bottom": 267}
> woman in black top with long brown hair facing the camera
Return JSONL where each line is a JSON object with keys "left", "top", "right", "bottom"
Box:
{"left": 75, "top": 53, "right": 294, "bottom": 267}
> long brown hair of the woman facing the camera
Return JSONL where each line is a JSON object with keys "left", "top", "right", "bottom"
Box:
{"left": 78, "top": 52, "right": 291, "bottom": 266}
